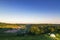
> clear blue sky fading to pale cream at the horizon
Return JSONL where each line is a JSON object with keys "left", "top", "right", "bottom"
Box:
{"left": 0, "top": 0, "right": 60, "bottom": 24}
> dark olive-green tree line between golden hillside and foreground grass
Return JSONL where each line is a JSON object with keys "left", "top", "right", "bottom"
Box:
{"left": 0, "top": 24, "right": 60, "bottom": 35}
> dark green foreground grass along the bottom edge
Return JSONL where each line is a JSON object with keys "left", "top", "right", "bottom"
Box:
{"left": 0, "top": 34, "right": 60, "bottom": 40}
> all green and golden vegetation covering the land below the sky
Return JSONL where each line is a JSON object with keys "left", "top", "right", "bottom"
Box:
{"left": 0, "top": 23, "right": 60, "bottom": 40}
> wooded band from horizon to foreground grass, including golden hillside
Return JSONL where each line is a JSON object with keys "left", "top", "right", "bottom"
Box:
{"left": 0, "top": 23, "right": 60, "bottom": 36}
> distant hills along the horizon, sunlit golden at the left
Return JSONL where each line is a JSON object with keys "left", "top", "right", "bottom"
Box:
{"left": 0, "top": 22, "right": 60, "bottom": 29}
